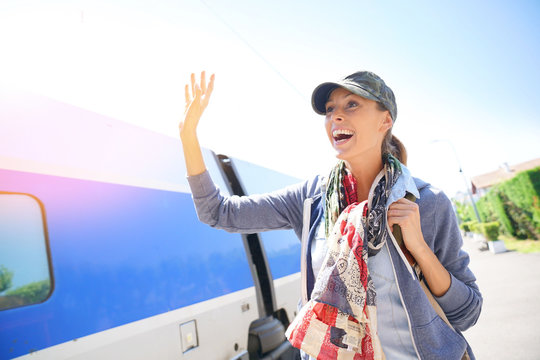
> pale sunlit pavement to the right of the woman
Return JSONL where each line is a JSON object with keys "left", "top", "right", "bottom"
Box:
{"left": 463, "top": 238, "right": 540, "bottom": 360}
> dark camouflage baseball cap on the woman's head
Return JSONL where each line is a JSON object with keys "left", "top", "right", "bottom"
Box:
{"left": 311, "top": 71, "right": 397, "bottom": 121}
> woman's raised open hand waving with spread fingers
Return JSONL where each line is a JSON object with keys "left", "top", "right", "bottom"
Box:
{"left": 180, "top": 71, "right": 215, "bottom": 137}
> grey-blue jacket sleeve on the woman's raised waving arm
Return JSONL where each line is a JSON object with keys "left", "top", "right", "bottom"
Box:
{"left": 188, "top": 171, "right": 306, "bottom": 235}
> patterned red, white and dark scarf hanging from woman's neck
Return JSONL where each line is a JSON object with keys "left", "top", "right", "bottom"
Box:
{"left": 286, "top": 155, "right": 401, "bottom": 360}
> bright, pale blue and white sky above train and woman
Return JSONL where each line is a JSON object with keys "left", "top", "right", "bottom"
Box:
{"left": 0, "top": 0, "right": 540, "bottom": 196}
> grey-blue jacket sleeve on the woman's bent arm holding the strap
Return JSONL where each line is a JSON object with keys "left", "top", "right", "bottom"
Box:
{"left": 434, "top": 191, "right": 482, "bottom": 331}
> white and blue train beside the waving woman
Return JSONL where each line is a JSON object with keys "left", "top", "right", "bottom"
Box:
{"left": 0, "top": 88, "right": 300, "bottom": 360}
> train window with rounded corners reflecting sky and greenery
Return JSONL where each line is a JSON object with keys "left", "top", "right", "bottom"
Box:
{"left": 0, "top": 192, "right": 52, "bottom": 311}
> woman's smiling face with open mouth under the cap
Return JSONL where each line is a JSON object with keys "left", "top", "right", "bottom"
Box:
{"left": 325, "top": 88, "right": 392, "bottom": 161}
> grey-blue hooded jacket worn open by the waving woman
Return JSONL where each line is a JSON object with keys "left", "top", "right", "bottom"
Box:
{"left": 188, "top": 167, "right": 482, "bottom": 360}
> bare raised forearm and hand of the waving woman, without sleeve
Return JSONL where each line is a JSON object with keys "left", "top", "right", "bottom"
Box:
{"left": 180, "top": 71, "right": 215, "bottom": 176}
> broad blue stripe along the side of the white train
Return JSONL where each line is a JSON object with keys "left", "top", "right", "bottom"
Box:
{"left": 0, "top": 170, "right": 300, "bottom": 359}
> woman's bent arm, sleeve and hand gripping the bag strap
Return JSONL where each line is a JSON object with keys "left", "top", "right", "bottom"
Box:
{"left": 388, "top": 192, "right": 482, "bottom": 331}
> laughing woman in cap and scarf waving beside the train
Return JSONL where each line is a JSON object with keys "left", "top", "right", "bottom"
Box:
{"left": 180, "top": 71, "right": 482, "bottom": 359}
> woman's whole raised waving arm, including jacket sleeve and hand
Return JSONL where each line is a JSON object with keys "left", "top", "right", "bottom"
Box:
{"left": 180, "top": 72, "right": 313, "bottom": 238}
